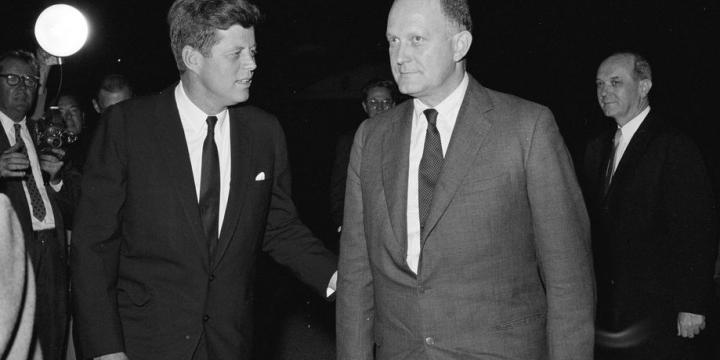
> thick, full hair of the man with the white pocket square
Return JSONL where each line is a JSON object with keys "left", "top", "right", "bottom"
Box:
{"left": 168, "top": 0, "right": 261, "bottom": 73}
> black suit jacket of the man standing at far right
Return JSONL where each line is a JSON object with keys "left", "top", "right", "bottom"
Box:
{"left": 585, "top": 110, "right": 717, "bottom": 349}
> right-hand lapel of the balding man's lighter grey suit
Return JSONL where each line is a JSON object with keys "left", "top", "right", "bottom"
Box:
{"left": 420, "top": 77, "right": 492, "bottom": 248}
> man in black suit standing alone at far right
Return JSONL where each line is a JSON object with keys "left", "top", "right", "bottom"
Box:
{"left": 585, "top": 53, "right": 717, "bottom": 360}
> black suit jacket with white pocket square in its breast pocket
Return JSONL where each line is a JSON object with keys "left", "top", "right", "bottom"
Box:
{"left": 72, "top": 87, "right": 336, "bottom": 360}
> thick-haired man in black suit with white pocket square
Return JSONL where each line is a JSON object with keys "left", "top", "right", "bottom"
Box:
{"left": 72, "top": 0, "right": 336, "bottom": 360}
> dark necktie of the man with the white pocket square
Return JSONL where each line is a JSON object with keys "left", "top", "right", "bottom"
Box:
{"left": 199, "top": 116, "right": 220, "bottom": 258}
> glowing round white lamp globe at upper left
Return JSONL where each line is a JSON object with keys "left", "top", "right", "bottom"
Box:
{"left": 35, "top": 4, "right": 88, "bottom": 57}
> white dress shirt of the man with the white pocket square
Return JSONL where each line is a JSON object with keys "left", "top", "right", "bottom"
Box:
{"left": 175, "top": 82, "right": 231, "bottom": 236}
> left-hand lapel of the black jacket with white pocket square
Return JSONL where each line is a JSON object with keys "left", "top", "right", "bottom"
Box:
{"left": 152, "top": 86, "right": 209, "bottom": 264}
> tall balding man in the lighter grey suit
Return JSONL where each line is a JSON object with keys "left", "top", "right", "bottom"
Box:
{"left": 337, "top": 0, "right": 594, "bottom": 360}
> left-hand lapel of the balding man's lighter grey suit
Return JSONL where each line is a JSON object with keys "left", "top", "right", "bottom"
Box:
{"left": 382, "top": 101, "right": 413, "bottom": 255}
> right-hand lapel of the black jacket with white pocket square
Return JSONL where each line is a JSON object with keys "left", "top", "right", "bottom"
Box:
{"left": 213, "top": 108, "right": 253, "bottom": 266}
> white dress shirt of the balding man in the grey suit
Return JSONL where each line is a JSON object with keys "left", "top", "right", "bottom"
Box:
{"left": 406, "top": 73, "right": 470, "bottom": 274}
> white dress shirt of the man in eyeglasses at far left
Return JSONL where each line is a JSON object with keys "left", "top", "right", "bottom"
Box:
{"left": 0, "top": 111, "right": 55, "bottom": 231}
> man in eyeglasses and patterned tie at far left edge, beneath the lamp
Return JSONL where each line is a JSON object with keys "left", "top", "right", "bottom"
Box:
{"left": 0, "top": 51, "right": 73, "bottom": 359}
